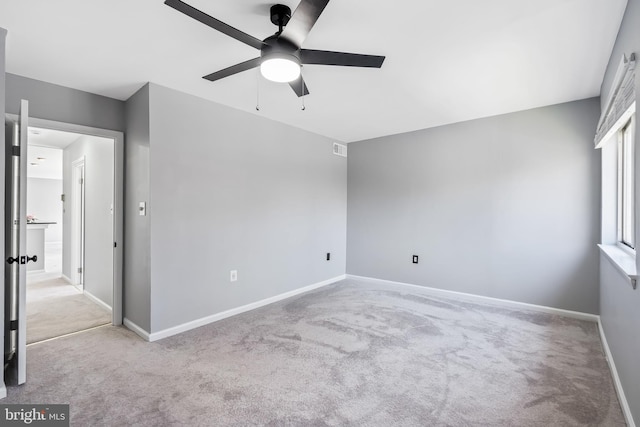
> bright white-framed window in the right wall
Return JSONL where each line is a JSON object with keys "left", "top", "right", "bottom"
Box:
{"left": 617, "top": 118, "right": 636, "bottom": 249}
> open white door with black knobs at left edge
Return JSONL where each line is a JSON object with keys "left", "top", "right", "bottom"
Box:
{"left": 4, "top": 100, "right": 32, "bottom": 385}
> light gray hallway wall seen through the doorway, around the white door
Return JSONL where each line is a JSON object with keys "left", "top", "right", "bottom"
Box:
{"left": 62, "top": 136, "right": 114, "bottom": 307}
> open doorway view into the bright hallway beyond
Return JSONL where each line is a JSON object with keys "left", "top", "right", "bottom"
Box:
{"left": 26, "top": 126, "right": 115, "bottom": 344}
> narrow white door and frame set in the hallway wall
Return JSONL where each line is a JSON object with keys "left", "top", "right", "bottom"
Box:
{"left": 70, "top": 156, "right": 86, "bottom": 290}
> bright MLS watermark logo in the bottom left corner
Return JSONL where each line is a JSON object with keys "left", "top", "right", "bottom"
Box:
{"left": 0, "top": 404, "right": 69, "bottom": 427}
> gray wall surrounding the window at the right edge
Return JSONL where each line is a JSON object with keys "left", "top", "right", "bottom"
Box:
{"left": 600, "top": 0, "right": 640, "bottom": 424}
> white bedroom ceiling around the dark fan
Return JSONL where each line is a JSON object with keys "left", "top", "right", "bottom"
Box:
{"left": 0, "top": 0, "right": 627, "bottom": 142}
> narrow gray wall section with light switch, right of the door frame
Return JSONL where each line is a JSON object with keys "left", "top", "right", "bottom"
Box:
{"left": 123, "top": 85, "right": 151, "bottom": 332}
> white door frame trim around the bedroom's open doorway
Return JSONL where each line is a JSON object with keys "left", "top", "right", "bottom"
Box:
{"left": 6, "top": 114, "right": 124, "bottom": 326}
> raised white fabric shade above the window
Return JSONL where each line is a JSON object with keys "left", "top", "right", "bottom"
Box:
{"left": 594, "top": 53, "right": 636, "bottom": 148}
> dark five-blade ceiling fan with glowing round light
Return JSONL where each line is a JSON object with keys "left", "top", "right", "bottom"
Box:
{"left": 164, "top": 0, "right": 385, "bottom": 96}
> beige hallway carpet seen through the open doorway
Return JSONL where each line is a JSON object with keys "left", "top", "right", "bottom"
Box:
{"left": 27, "top": 278, "right": 111, "bottom": 344}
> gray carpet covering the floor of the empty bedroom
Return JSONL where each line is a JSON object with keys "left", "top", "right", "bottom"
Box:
{"left": 2, "top": 279, "right": 625, "bottom": 426}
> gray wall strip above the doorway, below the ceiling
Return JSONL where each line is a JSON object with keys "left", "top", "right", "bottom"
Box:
{"left": 6, "top": 73, "right": 125, "bottom": 131}
